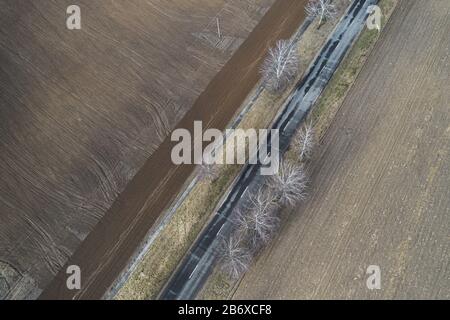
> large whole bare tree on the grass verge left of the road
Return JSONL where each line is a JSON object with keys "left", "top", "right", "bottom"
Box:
{"left": 261, "top": 40, "right": 299, "bottom": 93}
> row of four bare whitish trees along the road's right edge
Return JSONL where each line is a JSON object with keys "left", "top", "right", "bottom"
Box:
{"left": 219, "top": 124, "right": 315, "bottom": 279}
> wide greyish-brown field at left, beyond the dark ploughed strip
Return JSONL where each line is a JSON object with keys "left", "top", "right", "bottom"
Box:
{"left": 0, "top": 0, "right": 275, "bottom": 298}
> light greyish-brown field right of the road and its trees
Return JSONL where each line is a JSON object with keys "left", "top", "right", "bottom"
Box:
{"left": 233, "top": 0, "right": 450, "bottom": 299}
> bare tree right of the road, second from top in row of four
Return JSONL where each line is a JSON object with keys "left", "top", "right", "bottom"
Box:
{"left": 270, "top": 161, "right": 308, "bottom": 206}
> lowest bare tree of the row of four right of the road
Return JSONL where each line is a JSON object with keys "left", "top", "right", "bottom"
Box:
{"left": 219, "top": 233, "right": 252, "bottom": 279}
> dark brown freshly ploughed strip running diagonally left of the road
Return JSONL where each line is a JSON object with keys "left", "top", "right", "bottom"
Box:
{"left": 25, "top": 0, "right": 312, "bottom": 299}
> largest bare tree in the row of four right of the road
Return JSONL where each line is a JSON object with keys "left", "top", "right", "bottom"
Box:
{"left": 235, "top": 187, "right": 280, "bottom": 249}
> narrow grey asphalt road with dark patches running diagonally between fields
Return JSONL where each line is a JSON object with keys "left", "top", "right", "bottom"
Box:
{"left": 159, "top": 0, "right": 377, "bottom": 300}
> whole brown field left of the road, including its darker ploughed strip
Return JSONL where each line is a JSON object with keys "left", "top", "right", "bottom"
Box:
{"left": 0, "top": 0, "right": 310, "bottom": 299}
